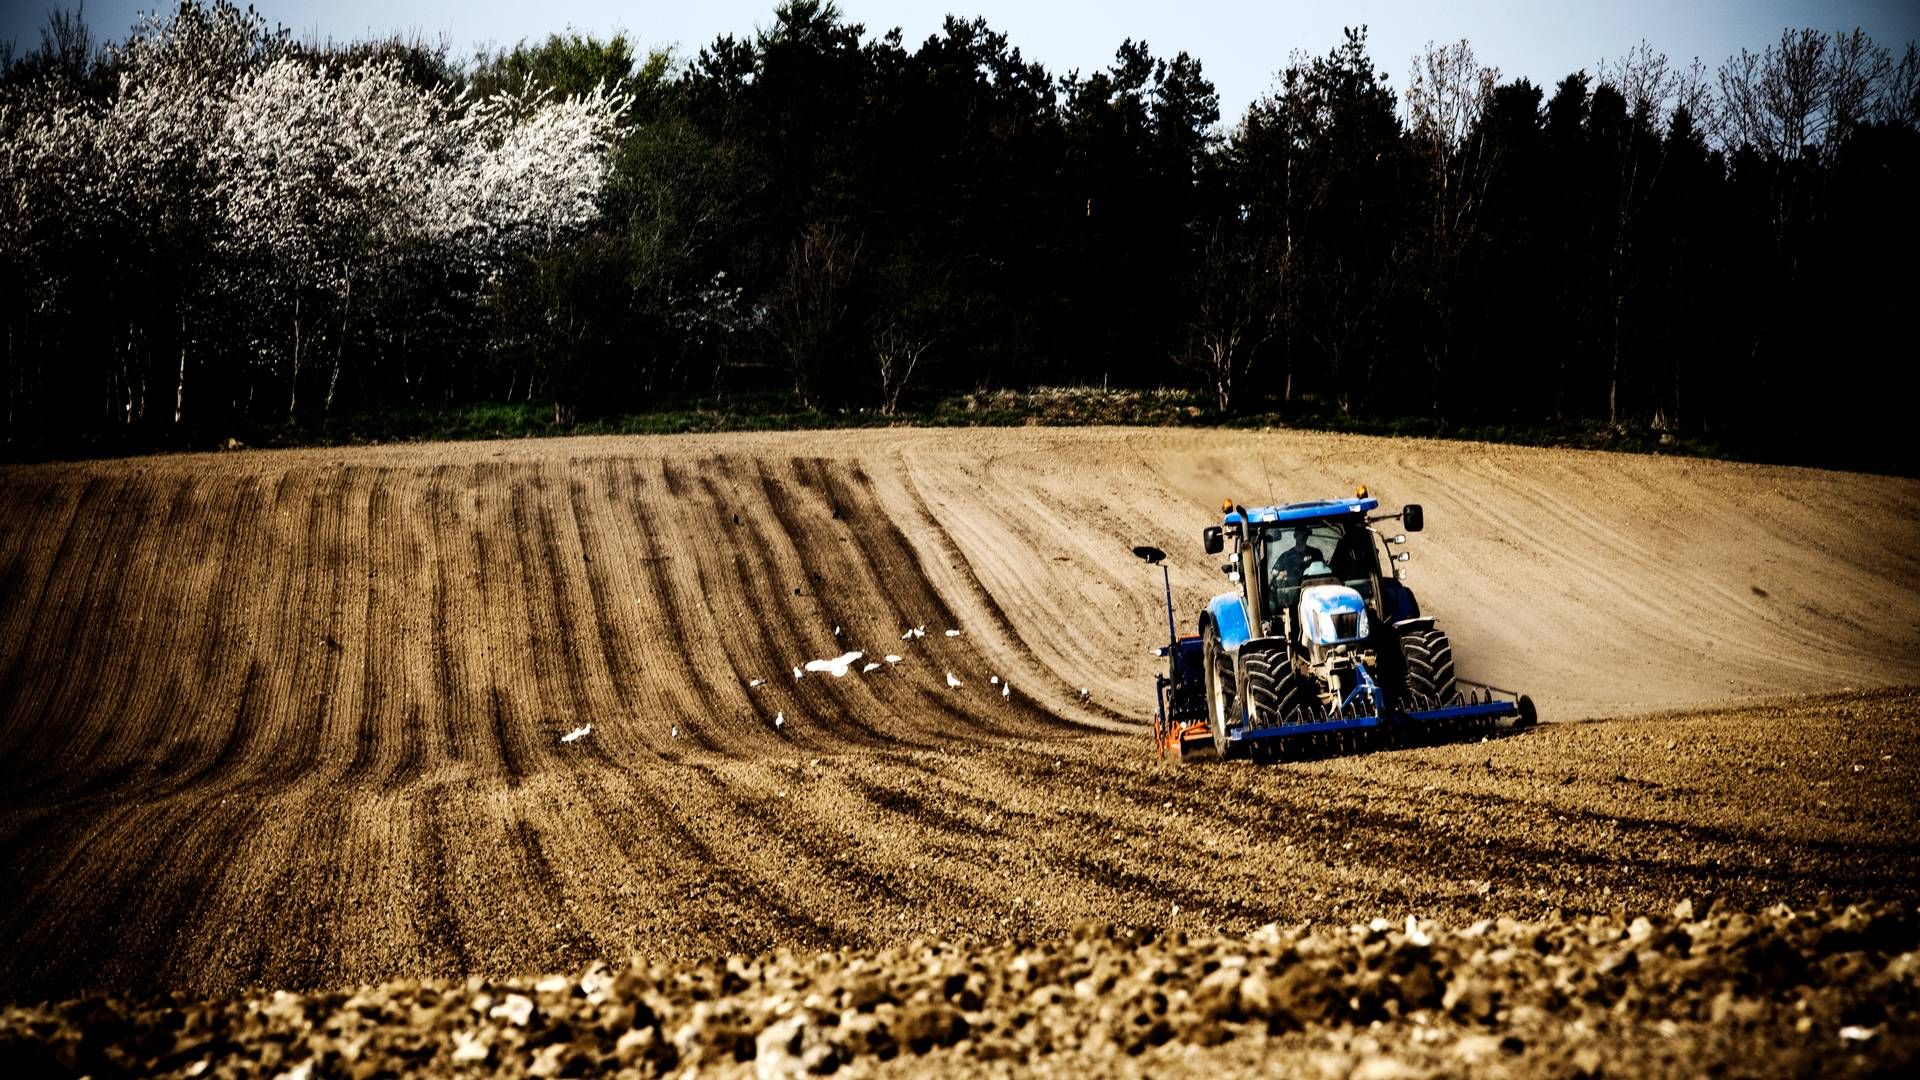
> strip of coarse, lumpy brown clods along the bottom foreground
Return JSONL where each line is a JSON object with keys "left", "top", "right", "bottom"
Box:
{"left": 0, "top": 903, "right": 1920, "bottom": 1078}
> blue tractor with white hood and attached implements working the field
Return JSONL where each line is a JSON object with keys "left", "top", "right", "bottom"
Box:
{"left": 1135, "top": 488, "right": 1536, "bottom": 761}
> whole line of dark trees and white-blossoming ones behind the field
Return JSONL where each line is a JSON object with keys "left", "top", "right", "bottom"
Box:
{"left": 0, "top": 0, "right": 1920, "bottom": 467}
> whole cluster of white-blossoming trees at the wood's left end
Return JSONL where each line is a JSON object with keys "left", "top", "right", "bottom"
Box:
{"left": 0, "top": 2, "right": 626, "bottom": 423}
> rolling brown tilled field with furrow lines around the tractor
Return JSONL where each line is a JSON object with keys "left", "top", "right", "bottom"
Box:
{"left": 0, "top": 429, "right": 1920, "bottom": 1068}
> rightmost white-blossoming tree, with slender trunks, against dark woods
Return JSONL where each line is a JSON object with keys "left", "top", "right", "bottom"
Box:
{"left": 215, "top": 58, "right": 624, "bottom": 415}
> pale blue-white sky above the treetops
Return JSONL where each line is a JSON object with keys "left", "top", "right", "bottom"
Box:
{"left": 0, "top": 0, "right": 1920, "bottom": 123}
